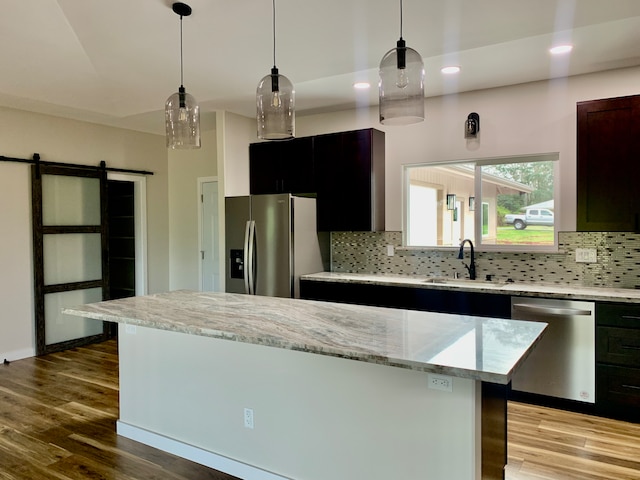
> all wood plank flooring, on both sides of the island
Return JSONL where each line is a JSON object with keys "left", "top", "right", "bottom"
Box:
{"left": 0, "top": 341, "right": 640, "bottom": 480}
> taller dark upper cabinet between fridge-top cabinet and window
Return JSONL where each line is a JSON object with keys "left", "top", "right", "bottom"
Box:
{"left": 314, "top": 128, "right": 385, "bottom": 232}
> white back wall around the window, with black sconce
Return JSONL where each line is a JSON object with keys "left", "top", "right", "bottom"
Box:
{"left": 296, "top": 67, "right": 640, "bottom": 231}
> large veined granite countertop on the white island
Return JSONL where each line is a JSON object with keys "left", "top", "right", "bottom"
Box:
{"left": 63, "top": 291, "right": 546, "bottom": 384}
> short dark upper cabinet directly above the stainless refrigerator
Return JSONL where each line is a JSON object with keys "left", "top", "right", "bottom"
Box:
{"left": 249, "top": 137, "right": 316, "bottom": 195}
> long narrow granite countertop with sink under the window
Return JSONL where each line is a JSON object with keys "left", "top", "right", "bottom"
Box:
{"left": 300, "top": 272, "right": 640, "bottom": 303}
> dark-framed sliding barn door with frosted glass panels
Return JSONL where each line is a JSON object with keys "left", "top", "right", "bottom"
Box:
{"left": 32, "top": 165, "right": 109, "bottom": 355}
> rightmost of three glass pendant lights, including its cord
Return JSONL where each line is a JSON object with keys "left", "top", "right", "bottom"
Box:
{"left": 379, "top": 0, "right": 424, "bottom": 125}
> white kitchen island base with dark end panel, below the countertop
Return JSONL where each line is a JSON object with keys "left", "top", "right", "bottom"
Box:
{"left": 118, "top": 324, "right": 506, "bottom": 480}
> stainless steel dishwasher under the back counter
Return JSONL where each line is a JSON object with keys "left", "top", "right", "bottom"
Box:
{"left": 511, "top": 297, "right": 596, "bottom": 403}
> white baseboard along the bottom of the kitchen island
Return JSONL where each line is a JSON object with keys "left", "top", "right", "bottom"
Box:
{"left": 116, "top": 420, "right": 291, "bottom": 480}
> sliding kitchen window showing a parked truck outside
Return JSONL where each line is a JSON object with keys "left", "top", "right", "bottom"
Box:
{"left": 404, "top": 153, "right": 558, "bottom": 250}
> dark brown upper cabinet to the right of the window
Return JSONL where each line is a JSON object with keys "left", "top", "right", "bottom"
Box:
{"left": 576, "top": 95, "right": 640, "bottom": 232}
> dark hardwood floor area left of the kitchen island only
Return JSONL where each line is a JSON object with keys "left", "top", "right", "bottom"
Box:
{"left": 0, "top": 340, "right": 235, "bottom": 480}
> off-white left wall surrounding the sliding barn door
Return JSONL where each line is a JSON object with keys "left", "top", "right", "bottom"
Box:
{"left": 0, "top": 108, "right": 169, "bottom": 361}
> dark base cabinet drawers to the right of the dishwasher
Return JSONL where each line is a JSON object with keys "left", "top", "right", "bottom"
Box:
{"left": 596, "top": 303, "right": 640, "bottom": 422}
